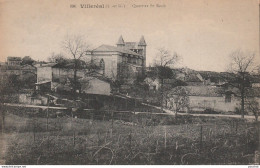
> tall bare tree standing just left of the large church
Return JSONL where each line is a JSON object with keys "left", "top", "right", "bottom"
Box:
{"left": 62, "top": 35, "right": 89, "bottom": 93}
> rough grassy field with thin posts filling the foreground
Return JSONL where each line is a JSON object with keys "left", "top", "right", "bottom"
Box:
{"left": 1, "top": 110, "right": 259, "bottom": 165}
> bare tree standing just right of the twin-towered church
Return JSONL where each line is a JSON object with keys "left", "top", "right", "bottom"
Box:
{"left": 154, "top": 48, "right": 180, "bottom": 111}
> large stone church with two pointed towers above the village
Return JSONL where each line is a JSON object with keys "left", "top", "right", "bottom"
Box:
{"left": 88, "top": 36, "right": 147, "bottom": 83}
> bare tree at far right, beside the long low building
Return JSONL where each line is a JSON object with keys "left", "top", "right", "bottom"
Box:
{"left": 229, "top": 50, "right": 255, "bottom": 118}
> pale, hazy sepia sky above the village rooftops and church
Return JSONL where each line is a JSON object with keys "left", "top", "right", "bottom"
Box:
{"left": 0, "top": 0, "right": 260, "bottom": 71}
